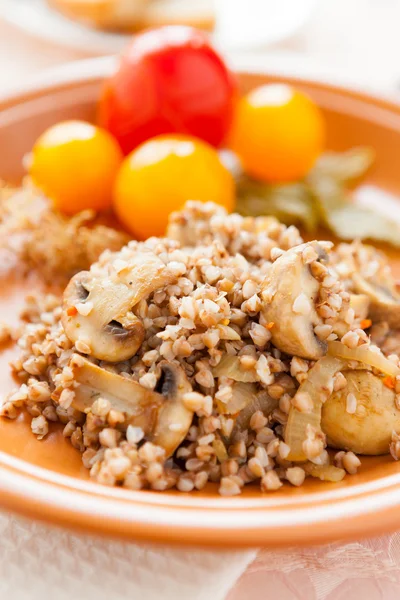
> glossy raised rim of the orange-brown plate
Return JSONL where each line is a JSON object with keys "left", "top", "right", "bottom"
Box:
{"left": 0, "top": 57, "right": 400, "bottom": 548}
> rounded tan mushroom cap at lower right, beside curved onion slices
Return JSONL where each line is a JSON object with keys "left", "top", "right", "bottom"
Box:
{"left": 321, "top": 370, "right": 400, "bottom": 456}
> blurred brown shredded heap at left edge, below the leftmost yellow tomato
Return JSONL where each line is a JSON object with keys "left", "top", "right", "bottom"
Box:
{"left": 0, "top": 181, "right": 129, "bottom": 284}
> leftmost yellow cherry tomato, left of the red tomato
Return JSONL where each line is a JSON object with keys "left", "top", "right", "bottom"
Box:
{"left": 29, "top": 121, "right": 122, "bottom": 214}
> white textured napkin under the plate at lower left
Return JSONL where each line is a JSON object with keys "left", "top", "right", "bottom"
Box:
{"left": 0, "top": 513, "right": 257, "bottom": 600}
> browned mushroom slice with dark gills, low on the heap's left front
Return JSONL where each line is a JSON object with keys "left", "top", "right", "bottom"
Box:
{"left": 70, "top": 354, "right": 193, "bottom": 457}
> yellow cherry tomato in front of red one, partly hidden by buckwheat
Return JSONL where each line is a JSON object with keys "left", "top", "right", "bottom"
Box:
{"left": 114, "top": 135, "right": 235, "bottom": 239}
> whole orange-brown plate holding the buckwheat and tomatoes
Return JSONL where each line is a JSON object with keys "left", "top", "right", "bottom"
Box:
{"left": 0, "top": 59, "right": 400, "bottom": 547}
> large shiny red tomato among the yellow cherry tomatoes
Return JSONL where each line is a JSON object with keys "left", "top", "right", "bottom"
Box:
{"left": 99, "top": 26, "right": 236, "bottom": 153}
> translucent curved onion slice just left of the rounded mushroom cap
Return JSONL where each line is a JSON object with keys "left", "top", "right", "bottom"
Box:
{"left": 285, "top": 356, "right": 345, "bottom": 461}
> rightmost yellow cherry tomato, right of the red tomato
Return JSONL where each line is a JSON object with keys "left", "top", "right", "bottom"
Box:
{"left": 229, "top": 84, "right": 325, "bottom": 182}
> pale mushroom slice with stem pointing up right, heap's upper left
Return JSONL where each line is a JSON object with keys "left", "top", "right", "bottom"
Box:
{"left": 62, "top": 251, "right": 176, "bottom": 362}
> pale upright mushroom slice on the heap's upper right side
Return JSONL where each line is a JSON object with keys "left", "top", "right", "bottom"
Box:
{"left": 262, "top": 242, "right": 327, "bottom": 360}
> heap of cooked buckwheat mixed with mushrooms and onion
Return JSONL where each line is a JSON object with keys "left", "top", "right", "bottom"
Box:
{"left": 2, "top": 202, "right": 400, "bottom": 495}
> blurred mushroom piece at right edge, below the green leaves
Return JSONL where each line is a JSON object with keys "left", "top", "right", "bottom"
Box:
{"left": 353, "top": 273, "right": 400, "bottom": 329}
